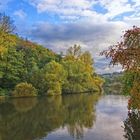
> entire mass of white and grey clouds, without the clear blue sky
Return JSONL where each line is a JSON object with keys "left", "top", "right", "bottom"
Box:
{"left": 20, "top": 0, "right": 140, "bottom": 73}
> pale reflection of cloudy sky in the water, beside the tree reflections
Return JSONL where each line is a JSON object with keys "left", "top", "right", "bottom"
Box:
{"left": 44, "top": 95, "right": 127, "bottom": 140}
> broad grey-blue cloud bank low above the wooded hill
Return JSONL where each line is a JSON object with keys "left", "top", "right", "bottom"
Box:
{"left": 26, "top": 21, "right": 127, "bottom": 73}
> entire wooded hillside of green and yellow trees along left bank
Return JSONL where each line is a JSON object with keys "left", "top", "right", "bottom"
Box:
{"left": 0, "top": 14, "right": 103, "bottom": 98}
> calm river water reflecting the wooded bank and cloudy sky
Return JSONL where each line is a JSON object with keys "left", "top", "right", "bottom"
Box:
{"left": 0, "top": 94, "right": 133, "bottom": 140}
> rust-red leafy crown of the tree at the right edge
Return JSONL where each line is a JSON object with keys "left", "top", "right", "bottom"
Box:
{"left": 101, "top": 26, "right": 140, "bottom": 71}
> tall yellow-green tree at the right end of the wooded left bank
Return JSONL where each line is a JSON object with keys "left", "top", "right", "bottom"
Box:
{"left": 62, "top": 45, "right": 102, "bottom": 93}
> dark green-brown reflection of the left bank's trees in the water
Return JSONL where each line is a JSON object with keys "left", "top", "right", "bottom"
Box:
{"left": 0, "top": 94, "right": 99, "bottom": 140}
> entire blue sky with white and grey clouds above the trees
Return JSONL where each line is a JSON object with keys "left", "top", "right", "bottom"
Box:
{"left": 0, "top": 0, "right": 140, "bottom": 73}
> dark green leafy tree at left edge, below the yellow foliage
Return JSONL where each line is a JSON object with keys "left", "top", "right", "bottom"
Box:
{"left": 0, "top": 47, "right": 26, "bottom": 89}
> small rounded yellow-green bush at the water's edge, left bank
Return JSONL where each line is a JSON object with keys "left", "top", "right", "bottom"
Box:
{"left": 12, "top": 82, "right": 37, "bottom": 97}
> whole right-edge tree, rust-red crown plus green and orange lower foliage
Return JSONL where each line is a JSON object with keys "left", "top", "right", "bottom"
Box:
{"left": 101, "top": 26, "right": 140, "bottom": 108}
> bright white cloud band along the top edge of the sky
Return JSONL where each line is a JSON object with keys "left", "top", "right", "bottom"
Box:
{"left": 26, "top": 0, "right": 140, "bottom": 20}
